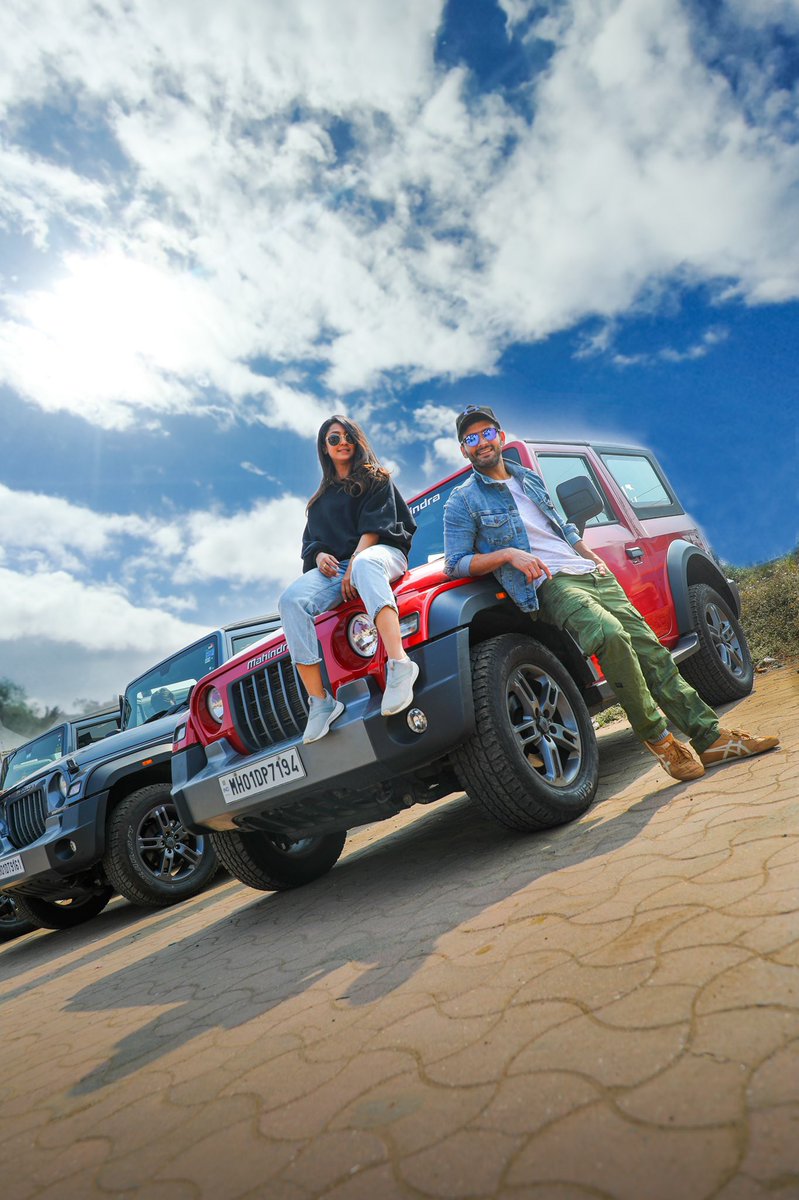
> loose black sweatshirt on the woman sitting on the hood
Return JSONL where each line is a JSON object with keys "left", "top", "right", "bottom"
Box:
{"left": 297, "top": 480, "right": 416, "bottom": 574}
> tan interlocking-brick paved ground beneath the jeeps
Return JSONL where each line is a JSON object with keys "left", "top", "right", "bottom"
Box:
{"left": 0, "top": 665, "right": 799, "bottom": 1200}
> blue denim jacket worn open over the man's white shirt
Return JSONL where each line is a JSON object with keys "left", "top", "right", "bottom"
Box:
{"left": 444, "top": 461, "right": 581, "bottom": 612}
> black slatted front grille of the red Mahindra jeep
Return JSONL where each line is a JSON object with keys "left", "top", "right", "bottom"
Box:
{"left": 229, "top": 659, "right": 308, "bottom": 750}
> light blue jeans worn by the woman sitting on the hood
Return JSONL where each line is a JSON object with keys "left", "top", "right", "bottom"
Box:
{"left": 277, "top": 544, "right": 408, "bottom": 666}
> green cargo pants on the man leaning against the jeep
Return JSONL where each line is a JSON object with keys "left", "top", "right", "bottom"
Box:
{"left": 539, "top": 571, "right": 719, "bottom": 754}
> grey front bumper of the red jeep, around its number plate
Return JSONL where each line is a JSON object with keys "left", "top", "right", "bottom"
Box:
{"left": 172, "top": 629, "right": 474, "bottom": 838}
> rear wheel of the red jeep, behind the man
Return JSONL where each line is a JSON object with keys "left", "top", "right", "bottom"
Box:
{"left": 680, "top": 583, "right": 755, "bottom": 706}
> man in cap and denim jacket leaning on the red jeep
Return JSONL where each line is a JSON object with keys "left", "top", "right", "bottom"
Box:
{"left": 444, "top": 404, "right": 780, "bottom": 780}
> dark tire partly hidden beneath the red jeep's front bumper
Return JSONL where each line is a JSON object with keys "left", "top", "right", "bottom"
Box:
{"left": 211, "top": 829, "right": 347, "bottom": 892}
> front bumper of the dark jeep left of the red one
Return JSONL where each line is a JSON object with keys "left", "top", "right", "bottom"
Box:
{"left": 0, "top": 794, "right": 104, "bottom": 899}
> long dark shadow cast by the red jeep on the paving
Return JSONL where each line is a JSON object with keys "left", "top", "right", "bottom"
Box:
{"left": 60, "top": 734, "right": 685, "bottom": 1096}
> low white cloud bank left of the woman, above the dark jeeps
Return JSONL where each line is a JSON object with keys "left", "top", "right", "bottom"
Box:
{"left": 0, "top": 477, "right": 305, "bottom": 708}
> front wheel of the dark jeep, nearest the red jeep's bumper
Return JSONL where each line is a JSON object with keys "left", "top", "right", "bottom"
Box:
{"left": 103, "top": 784, "right": 220, "bottom": 908}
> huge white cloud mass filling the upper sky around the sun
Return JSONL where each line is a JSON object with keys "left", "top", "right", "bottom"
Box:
{"left": 0, "top": 0, "right": 799, "bottom": 432}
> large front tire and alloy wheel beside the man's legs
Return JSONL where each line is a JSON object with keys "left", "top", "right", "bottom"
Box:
{"left": 451, "top": 634, "right": 599, "bottom": 832}
